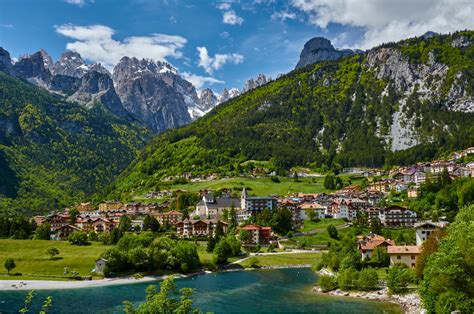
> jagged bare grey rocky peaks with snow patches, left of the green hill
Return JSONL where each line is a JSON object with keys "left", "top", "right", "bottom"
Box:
{"left": 0, "top": 48, "right": 269, "bottom": 133}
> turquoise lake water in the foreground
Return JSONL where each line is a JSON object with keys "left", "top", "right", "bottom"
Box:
{"left": 0, "top": 269, "right": 400, "bottom": 313}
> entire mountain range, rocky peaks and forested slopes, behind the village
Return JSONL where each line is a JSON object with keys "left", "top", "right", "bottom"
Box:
{"left": 0, "top": 31, "right": 474, "bottom": 212}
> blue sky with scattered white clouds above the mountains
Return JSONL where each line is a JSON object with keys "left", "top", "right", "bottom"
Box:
{"left": 0, "top": 0, "right": 474, "bottom": 92}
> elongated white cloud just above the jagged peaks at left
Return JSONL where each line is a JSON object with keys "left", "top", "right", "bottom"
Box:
{"left": 55, "top": 24, "right": 187, "bottom": 69}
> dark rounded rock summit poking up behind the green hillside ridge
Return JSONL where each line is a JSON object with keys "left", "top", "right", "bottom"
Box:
{"left": 296, "top": 37, "right": 355, "bottom": 69}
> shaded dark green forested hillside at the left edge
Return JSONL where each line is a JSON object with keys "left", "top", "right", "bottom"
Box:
{"left": 0, "top": 72, "right": 149, "bottom": 213}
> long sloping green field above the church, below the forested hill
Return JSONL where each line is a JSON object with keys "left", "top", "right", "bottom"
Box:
{"left": 167, "top": 175, "right": 360, "bottom": 196}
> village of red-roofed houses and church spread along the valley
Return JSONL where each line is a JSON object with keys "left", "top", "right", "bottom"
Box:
{"left": 30, "top": 148, "right": 474, "bottom": 267}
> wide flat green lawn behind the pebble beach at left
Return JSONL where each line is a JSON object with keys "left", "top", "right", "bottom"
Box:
{"left": 0, "top": 239, "right": 108, "bottom": 280}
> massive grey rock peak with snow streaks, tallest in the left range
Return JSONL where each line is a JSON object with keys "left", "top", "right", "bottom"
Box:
{"left": 113, "top": 57, "right": 192, "bottom": 132}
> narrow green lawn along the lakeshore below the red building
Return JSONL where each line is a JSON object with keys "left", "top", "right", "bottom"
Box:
{"left": 239, "top": 252, "right": 322, "bottom": 268}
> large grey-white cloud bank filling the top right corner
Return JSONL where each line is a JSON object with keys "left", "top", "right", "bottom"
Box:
{"left": 291, "top": 0, "right": 474, "bottom": 49}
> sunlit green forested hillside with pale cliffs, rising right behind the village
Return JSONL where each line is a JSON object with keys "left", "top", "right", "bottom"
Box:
{"left": 105, "top": 31, "right": 474, "bottom": 197}
